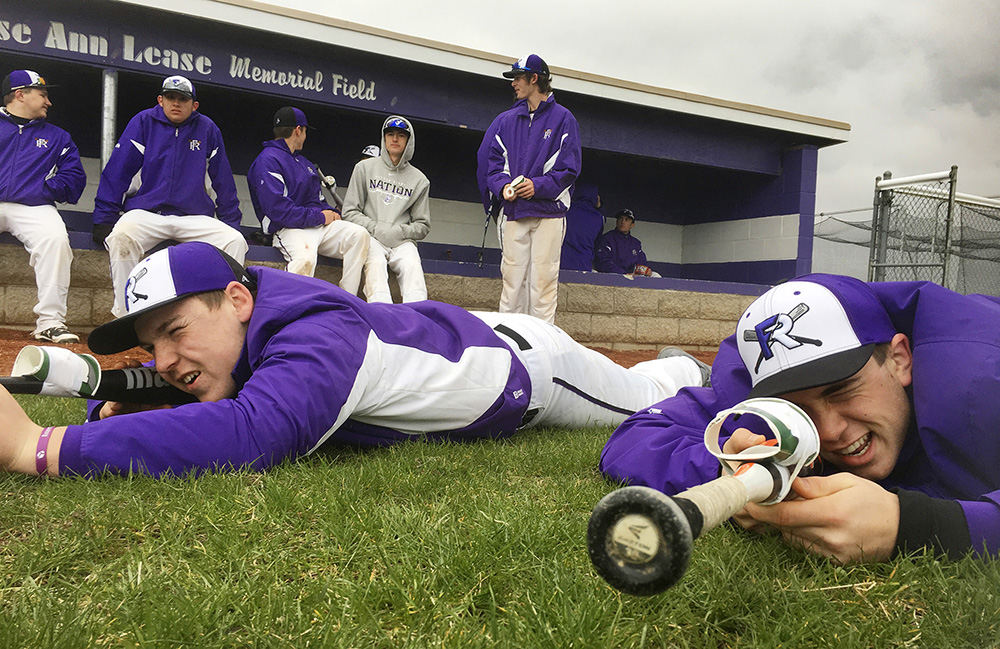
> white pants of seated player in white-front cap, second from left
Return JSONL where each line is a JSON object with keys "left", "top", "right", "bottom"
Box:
{"left": 104, "top": 210, "right": 248, "bottom": 318}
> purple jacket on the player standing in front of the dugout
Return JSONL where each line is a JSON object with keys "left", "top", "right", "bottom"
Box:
{"left": 484, "top": 94, "right": 581, "bottom": 221}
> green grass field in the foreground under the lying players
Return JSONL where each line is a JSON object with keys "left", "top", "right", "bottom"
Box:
{"left": 0, "top": 397, "right": 1000, "bottom": 649}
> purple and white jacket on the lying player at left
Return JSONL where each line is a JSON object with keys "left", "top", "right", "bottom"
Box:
{"left": 59, "top": 267, "right": 531, "bottom": 477}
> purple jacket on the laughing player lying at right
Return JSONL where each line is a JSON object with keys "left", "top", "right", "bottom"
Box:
{"left": 600, "top": 282, "right": 1000, "bottom": 553}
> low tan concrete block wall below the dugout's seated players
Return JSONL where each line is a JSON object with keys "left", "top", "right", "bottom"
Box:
{"left": 0, "top": 244, "right": 753, "bottom": 350}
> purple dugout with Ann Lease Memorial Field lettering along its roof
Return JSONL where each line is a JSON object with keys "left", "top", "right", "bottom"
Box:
{"left": 0, "top": 0, "right": 850, "bottom": 292}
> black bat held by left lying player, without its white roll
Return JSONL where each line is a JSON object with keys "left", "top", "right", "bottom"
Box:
{"left": 0, "top": 367, "right": 197, "bottom": 405}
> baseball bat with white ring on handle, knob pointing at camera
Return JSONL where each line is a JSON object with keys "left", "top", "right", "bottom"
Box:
{"left": 587, "top": 398, "right": 819, "bottom": 595}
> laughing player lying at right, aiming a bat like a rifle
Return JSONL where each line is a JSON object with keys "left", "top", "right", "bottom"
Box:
{"left": 601, "top": 275, "right": 1000, "bottom": 562}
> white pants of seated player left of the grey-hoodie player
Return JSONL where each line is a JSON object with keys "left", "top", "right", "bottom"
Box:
{"left": 272, "top": 219, "right": 370, "bottom": 295}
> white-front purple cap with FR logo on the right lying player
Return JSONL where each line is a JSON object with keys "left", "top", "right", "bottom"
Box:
{"left": 736, "top": 274, "right": 896, "bottom": 397}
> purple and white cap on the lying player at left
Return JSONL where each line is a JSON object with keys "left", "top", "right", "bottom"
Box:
{"left": 87, "top": 241, "right": 254, "bottom": 354}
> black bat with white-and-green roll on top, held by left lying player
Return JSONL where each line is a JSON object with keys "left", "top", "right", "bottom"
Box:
{"left": 0, "top": 345, "right": 196, "bottom": 405}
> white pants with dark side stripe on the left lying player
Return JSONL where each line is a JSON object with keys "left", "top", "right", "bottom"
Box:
{"left": 473, "top": 312, "right": 702, "bottom": 428}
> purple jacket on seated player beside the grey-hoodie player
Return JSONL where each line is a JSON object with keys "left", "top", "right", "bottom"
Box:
{"left": 247, "top": 140, "right": 338, "bottom": 234}
